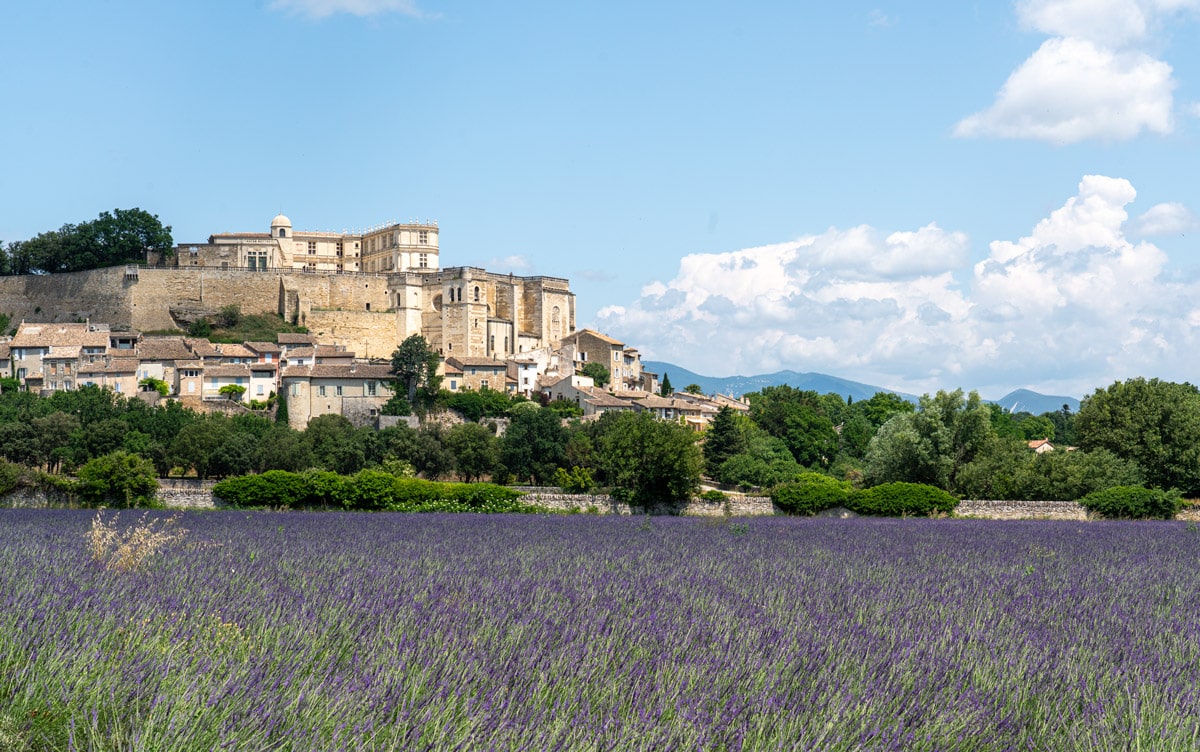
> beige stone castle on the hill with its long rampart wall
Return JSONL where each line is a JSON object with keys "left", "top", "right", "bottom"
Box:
{"left": 0, "top": 215, "right": 575, "bottom": 360}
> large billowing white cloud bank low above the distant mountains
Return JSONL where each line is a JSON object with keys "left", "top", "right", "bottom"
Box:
{"left": 596, "top": 175, "right": 1200, "bottom": 396}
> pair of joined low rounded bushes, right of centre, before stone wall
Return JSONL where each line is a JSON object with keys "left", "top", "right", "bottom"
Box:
{"left": 770, "top": 473, "right": 959, "bottom": 517}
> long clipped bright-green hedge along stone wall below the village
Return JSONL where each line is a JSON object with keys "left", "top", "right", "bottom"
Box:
{"left": 212, "top": 470, "right": 545, "bottom": 512}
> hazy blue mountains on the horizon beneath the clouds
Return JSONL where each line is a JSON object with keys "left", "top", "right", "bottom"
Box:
{"left": 642, "top": 360, "right": 1079, "bottom": 415}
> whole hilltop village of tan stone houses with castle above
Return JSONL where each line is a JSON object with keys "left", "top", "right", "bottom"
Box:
{"left": 0, "top": 215, "right": 746, "bottom": 431}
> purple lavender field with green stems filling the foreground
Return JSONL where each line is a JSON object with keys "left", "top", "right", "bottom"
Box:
{"left": 0, "top": 510, "right": 1200, "bottom": 751}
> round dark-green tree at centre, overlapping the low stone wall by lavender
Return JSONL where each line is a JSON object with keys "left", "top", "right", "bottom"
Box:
{"left": 592, "top": 411, "right": 702, "bottom": 507}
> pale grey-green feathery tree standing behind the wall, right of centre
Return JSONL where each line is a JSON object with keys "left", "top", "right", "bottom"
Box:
{"left": 866, "top": 389, "right": 996, "bottom": 491}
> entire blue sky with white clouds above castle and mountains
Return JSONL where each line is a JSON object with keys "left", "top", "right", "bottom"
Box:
{"left": 0, "top": 0, "right": 1200, "bottom": 397}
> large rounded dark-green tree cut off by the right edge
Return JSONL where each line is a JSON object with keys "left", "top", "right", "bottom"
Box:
{"left": 1075, "top": 378, "right": 1200, "bottom": 495}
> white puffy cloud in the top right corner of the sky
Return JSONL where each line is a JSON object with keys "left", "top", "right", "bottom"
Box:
{"left": 954, "top": 0, "right": 1200, "bottom": 144}
